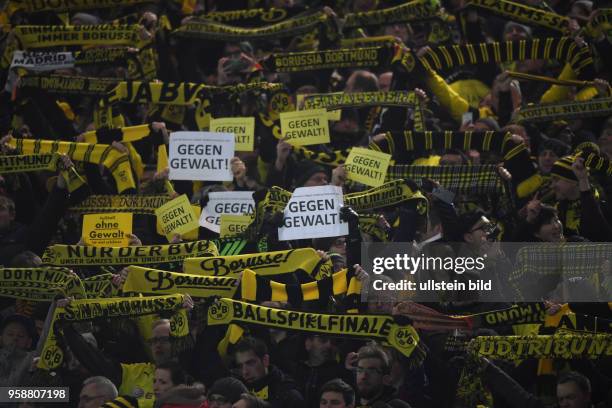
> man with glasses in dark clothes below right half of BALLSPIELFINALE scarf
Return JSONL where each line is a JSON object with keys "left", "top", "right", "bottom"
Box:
{"left": 354, "top": 344, "right": 410, "bottom": 408}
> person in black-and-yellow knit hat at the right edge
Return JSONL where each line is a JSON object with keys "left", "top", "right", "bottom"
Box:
{"left": 551, "top": 156, "right": 612, "bottom": 242}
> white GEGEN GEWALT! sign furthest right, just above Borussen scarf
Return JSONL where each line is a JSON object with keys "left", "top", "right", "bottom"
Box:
{"left": 278, "top": 186, "right": 348, "bottom": 241}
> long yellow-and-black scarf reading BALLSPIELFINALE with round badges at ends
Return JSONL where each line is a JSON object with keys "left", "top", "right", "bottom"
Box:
{"left": 208, "top": 299, "right": 425, "bottom": 366}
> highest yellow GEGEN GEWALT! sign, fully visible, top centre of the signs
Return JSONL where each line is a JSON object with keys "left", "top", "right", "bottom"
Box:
{"left": 280, "top": 109, "right": 330, "bottom": 146}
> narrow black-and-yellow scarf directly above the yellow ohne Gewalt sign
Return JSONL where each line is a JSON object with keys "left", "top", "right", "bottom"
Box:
{"left": 69, "top": 195, "right": 171, "bottom": 215}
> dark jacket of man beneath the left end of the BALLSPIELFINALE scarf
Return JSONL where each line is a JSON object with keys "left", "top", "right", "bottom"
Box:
{"left": 247, "top": 365, "right": 306, "bottom": 408}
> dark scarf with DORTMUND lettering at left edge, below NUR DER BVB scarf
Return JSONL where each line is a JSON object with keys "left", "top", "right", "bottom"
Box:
{"left": 0, "top": 266, "right": 85, "bottom": 301}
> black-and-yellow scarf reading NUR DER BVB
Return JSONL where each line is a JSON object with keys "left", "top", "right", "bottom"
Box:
{"left": 42, "top": 241, "right": 217, "bottom": 266}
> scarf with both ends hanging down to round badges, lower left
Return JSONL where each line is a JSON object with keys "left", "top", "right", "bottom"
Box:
{"left": 38, "top": 295, "right": 189, "bottom": 370}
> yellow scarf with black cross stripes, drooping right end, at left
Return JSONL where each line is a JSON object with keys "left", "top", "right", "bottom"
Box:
{"left": 9, "top": 139, "right": 136, "bottom": 192}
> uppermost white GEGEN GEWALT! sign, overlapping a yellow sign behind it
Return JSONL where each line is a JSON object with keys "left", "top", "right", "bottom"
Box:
{"left": 168, "top": 132, "right": 235, "bottom": 181}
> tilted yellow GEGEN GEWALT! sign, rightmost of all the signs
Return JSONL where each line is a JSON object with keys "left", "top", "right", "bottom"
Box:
{"left": 344, "top": 147, "right": 391, "bottom": 187}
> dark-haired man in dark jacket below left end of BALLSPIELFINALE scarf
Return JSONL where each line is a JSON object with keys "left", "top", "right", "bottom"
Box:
{"left": 234, "top": 337, "right": 306, "bottom": 408}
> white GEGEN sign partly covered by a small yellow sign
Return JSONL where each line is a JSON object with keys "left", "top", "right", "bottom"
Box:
{"left": 200, "top": 191, "right": 255, "bottom": 233}
